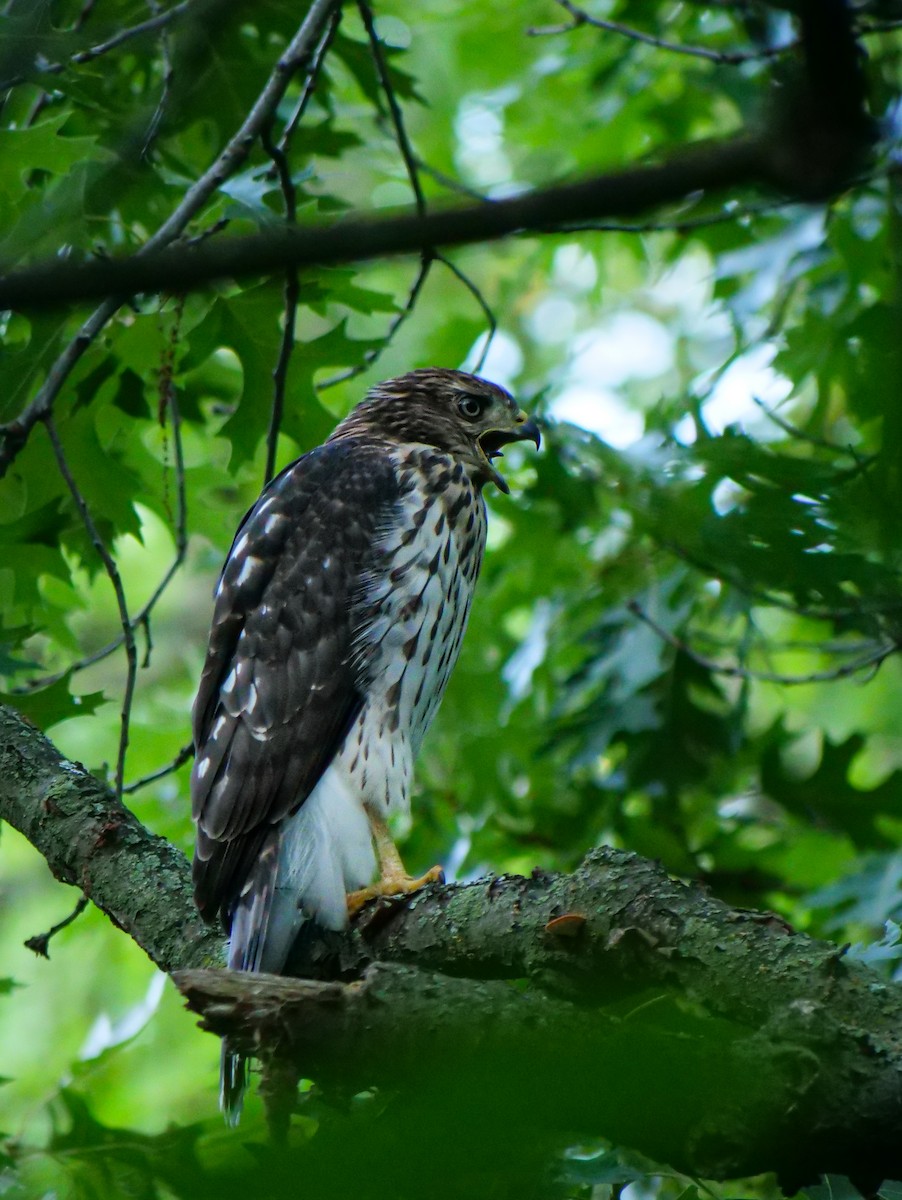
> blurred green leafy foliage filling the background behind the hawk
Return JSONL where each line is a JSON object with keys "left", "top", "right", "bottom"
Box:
{"left": 0, "top": 0, "right": 902, "bottom": 1200}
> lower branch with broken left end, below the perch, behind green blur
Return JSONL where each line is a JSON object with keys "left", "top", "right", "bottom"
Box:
{"left": 175, "top": 936, "right": 902, "bottom": 1190}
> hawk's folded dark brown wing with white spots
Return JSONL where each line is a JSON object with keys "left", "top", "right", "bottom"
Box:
{"left": 191, "top": 439, "right": 398, "bottom": 920}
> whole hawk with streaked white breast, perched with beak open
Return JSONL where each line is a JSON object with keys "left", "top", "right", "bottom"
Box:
{"left": 191, "top": 368, "right": 540, "bottom": 1122}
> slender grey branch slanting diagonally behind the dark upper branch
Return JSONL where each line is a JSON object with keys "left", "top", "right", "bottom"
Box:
{"left": 0, "top": 0, "right": 339, "bottom": 479}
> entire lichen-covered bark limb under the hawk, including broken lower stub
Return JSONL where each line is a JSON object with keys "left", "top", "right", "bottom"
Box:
{"left": 0, "top": 709, "right": 902, "bottom": 1189}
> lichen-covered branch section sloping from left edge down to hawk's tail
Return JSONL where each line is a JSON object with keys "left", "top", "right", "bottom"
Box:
{"left": 0, "top": 706, "right": 222, "bottom": 971}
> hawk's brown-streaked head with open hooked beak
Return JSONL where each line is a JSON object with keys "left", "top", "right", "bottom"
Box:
{"left": 332, "top": 367, "right": 541, "bottom": 492}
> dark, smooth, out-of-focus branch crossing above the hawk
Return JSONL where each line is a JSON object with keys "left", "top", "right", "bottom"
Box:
{"left": 0, "top": 0, "right": 873, "bottom": 308}
